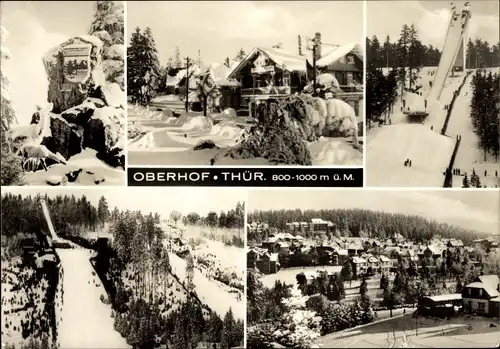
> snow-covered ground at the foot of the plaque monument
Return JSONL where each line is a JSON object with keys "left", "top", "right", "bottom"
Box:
{"left": 23, "top": 149, "right": 125, "bottom": 186}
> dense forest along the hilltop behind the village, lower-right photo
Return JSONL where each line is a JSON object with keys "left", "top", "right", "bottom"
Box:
{"left": 247, "top": 209, "right": 490, "bottom": 243}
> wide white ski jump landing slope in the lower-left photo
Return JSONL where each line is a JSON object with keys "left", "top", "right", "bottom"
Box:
{"left": 56, "top": 248, "right": 130, "bottom": 349}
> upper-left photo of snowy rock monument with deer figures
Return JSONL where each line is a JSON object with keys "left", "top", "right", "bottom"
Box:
{"left": 1, "top": 1, "right": 126, "bottom": 186}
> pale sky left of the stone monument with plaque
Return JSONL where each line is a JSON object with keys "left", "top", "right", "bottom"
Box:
{"left": 0, "top": 1, "right": 94, "bottom": 123}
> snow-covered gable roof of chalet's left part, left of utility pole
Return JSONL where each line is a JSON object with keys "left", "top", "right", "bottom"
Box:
{"left": 228, "top": 47, "right": 307, "bottom": 79}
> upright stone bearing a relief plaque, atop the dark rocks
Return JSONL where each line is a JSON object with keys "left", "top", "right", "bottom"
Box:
{"left": 43, "top": 35, "right": 103, "bottom": 113}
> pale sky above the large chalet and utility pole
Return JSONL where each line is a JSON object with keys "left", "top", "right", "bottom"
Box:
{"left": 127, "top": 1, "right": 363, "bottom": 64}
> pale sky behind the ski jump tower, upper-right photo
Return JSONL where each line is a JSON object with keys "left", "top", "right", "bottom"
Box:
{"left": 366, "top": 0, "right": 500, "bottom": 49}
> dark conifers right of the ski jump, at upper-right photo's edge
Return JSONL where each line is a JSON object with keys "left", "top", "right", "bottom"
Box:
{"left": 470, "top": 70, "right": 500, "bottom": 161}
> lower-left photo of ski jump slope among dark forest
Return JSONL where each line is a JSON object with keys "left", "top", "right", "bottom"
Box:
{"left": 1, "top": 187, "right": 246, "bottom": 349}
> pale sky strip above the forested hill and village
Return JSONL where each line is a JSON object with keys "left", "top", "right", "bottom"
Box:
{"left": 248, "top": 189, "right": 500, "bottom": 234}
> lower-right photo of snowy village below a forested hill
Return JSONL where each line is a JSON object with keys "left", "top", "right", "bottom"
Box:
{"left": 246, "top": 188, "right": 500, "bottom": 349}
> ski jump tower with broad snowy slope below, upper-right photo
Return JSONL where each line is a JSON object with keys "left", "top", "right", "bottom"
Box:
{"left": 366, "top": 3, "right": 471, "bottom": 187}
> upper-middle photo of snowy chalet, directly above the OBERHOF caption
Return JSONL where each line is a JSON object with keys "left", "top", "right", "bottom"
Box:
{"left": 127, "top": 1, "right": 364, "bottom": 168}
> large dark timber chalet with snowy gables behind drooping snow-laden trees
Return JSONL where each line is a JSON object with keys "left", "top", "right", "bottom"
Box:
{"left": 227, "top": 33, "right": 363, "bottom": 116}
